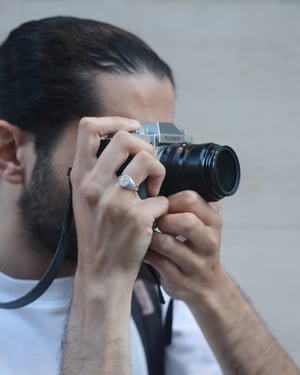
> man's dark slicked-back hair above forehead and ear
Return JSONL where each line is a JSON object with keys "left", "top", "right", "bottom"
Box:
{"left": 0, "top": 17, "right": 174, "bottom": 147}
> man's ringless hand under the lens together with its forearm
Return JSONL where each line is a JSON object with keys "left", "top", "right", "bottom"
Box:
{"left": 146, "top": 191, "right": 299, "bottom": 375}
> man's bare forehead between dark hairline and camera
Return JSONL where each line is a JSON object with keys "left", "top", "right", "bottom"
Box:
{"left": 96, "top": 73, "right": 175, "bottom": 123}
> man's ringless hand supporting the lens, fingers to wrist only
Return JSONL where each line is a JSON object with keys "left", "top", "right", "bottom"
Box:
{"left": 145, "top": 191, "right": 222, "bottom": 304}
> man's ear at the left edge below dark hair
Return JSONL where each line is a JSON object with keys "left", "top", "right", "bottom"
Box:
{"left": 0, "top": 119, "right": 24, "bottom": 184}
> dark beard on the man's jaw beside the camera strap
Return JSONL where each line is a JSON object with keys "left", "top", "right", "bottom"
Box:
{"left": 18, "top": 152, "right": 77, "bottom": 262}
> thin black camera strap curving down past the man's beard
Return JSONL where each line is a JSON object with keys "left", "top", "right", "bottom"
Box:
{"left": 0, "top": 169, "right": 73, "bottom": 309}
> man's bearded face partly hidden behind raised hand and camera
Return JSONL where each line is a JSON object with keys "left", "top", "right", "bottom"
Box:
{"left": 19, "top": 73, "right": 175, "bottom": 261}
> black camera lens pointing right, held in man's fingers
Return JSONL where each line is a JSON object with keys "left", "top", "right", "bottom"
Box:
{"left": 159, "top": 143, "right": 240, "bottom": 202}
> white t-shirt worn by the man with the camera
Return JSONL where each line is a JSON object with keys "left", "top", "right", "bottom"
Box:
{"left": 0, "top": 273, "right": 222, "bottom": 375}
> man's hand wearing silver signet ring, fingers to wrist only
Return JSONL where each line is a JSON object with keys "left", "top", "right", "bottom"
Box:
{"left": 71, "top": 117, "right": 168, "bottom": 282}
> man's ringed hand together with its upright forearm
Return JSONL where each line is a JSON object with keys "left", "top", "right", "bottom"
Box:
{"left": 62, "top": 117, "right": 168, "bottom": 375}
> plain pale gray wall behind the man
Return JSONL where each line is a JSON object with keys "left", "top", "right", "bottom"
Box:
{"left": 0, "top": 0, "right": 300, "bottom": 366}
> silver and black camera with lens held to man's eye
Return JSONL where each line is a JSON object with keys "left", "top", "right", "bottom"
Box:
{"left": 98, "top": 122, "right": 240, "bottom": 202}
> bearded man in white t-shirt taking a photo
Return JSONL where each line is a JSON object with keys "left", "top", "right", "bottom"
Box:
{"left": 0, "top": 17, "right": 298, "bottom": 375}
